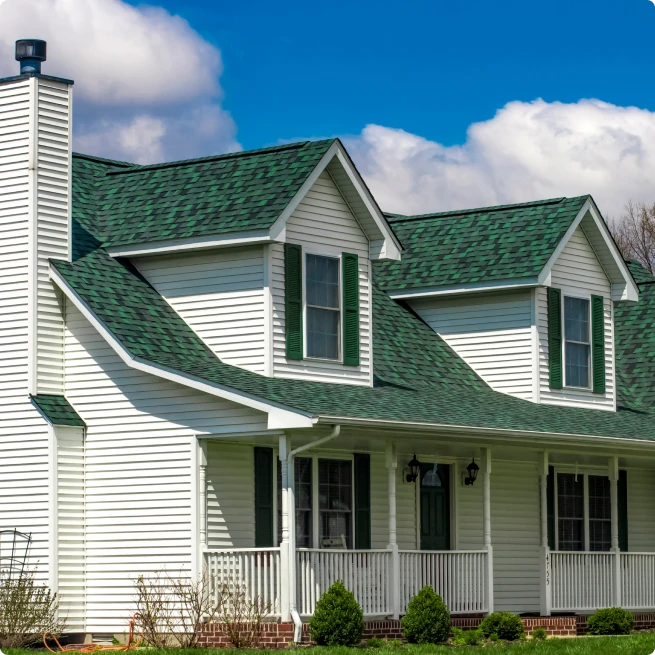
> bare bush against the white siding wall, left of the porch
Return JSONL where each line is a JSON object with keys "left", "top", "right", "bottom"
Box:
{"left": 135, "top": 570, "right": 220, "bottom": 648}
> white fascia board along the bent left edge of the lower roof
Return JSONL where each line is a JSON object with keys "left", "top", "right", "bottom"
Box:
{"left": 50, "top": 266, "right": 315, "bottom": 429}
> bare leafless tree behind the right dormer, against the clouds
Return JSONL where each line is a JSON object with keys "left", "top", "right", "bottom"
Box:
{"left": 608, "top": 201, "right": 655, "bottom": 274}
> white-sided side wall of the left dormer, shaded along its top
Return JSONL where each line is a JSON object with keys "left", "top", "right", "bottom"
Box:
{"left": 134, "top": 246, "right": 266, "bottom": 373}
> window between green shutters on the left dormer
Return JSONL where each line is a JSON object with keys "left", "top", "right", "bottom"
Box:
{"left": 305, "top": 255, "right": 341, "bottom": 360}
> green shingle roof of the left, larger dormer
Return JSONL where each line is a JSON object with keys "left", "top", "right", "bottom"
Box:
{"left": 76, "top": 139, "right": 336, "bottom": 246}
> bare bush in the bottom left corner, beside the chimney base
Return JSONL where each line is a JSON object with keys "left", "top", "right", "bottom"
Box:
{"left": 0, "top": 571, "right": 66, "bottom": 648}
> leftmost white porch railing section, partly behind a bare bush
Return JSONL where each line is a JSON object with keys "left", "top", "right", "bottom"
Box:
{"left": 205, "top": 548, "right": 281, "bottom": 616}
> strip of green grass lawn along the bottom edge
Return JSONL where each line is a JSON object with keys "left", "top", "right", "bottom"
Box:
{"left": 10, "top": 632, "right": 655, "bottom": 655}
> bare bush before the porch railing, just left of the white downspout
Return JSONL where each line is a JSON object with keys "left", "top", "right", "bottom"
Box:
{"left": 219, "top": 580, "right": 272, "bottom": 648}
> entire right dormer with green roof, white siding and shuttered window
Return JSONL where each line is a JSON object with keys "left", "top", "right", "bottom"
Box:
{"left": 376, "top": 196, "right": 638, "bottom": 410}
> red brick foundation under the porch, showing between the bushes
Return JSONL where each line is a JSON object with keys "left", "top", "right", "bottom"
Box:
{"left": 200, "top": 614, "right": 655, "bottom": 650}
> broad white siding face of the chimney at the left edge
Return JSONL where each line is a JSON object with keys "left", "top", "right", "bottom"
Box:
{"left": 0, "top": 80, "right": 49, "bottom": 580}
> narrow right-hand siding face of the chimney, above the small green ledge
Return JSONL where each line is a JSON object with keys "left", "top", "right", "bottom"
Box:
{"left": 36, "top": 78, "right": 71, "bottom": 394}
